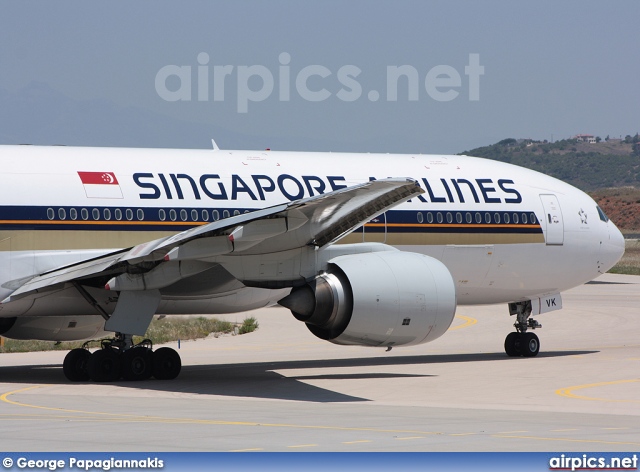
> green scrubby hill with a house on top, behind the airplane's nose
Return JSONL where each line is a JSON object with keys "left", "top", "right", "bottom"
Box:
{"left": 462, "top": 134, "right": 640, "bottom": 192}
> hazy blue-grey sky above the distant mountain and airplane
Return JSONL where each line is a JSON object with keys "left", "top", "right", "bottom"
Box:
{"left": 0, "top": 0, "right": 640, "bottom": 153}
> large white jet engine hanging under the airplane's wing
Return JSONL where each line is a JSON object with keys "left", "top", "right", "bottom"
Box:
{"left": 278, "top": 251, "right": 456, "bottom": 346}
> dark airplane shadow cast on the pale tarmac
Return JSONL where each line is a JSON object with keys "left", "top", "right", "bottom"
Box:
{"left": 0, "top": 351, "right": 598, "bottom": 403}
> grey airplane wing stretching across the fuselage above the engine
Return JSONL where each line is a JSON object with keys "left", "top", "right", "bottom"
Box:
{"left": 2, "top": 179, "right": 423, "bottom": 303}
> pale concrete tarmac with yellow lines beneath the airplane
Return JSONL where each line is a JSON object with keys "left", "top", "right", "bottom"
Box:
{"left": 0, "top": 274, "right": 640, "bottom": 452}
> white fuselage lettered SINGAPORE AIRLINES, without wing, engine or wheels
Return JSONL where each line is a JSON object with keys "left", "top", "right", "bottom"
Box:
{"left": 0, "top": 146, "right": 624, "bottom": 316}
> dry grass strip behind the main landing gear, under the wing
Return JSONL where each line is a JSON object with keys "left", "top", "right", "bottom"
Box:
{"left": 0, "top": 317, "right": 244, "bottom": 353}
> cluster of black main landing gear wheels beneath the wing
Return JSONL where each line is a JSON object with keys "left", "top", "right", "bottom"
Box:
{"left": 62, "top": 333, "right": 182, "bottom": 382}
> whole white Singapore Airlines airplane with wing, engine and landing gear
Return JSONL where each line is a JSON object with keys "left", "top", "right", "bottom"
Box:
{"left": 0, "top": 142, "right": 624, "bottom": 382}
